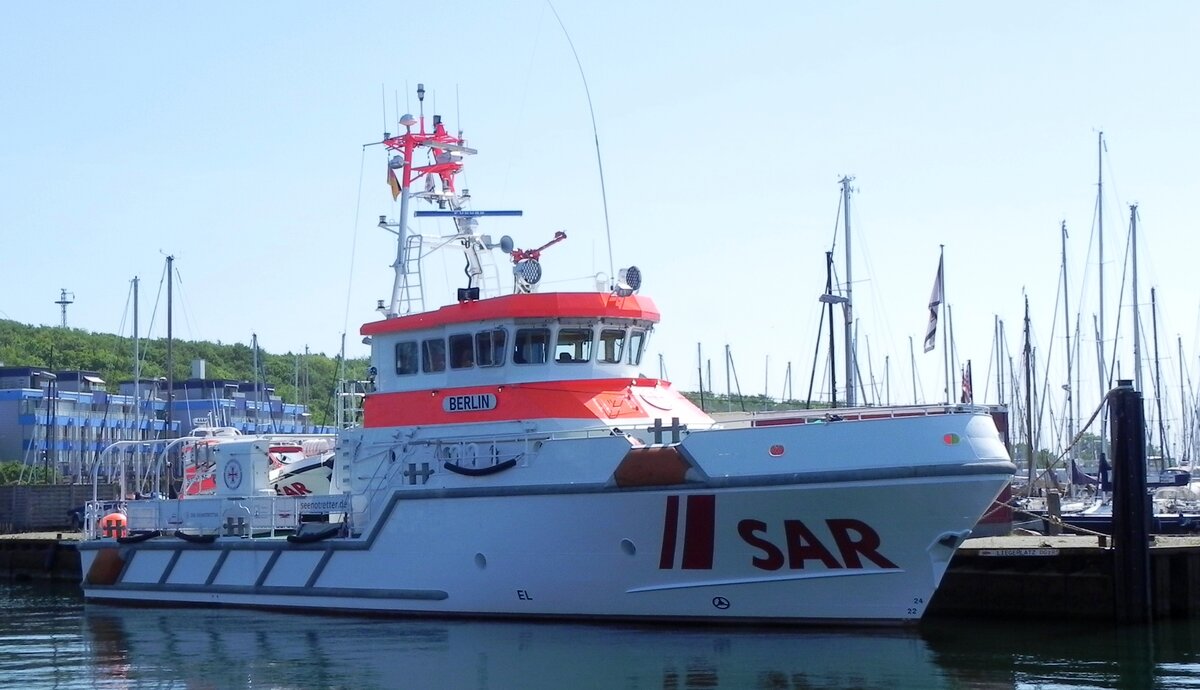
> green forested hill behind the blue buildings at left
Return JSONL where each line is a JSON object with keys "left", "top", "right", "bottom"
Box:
{"left": 0, "top": 319, "right": 367, "bottom": 424}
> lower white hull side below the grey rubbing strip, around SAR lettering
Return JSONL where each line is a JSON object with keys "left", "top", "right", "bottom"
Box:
{"left": 84, "top": 478, "right": 1000, "bottom": 620}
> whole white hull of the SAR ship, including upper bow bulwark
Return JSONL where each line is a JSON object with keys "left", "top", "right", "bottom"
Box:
{"left": 80, "top": 408, "right": 1012, "bottom": 623}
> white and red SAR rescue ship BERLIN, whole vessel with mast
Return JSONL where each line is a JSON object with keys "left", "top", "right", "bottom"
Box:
{"left": 79, "top": 89, "right": 1014, "bottom": 623}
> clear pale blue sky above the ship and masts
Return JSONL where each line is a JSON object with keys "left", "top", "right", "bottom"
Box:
{"left": 0, "top": 0, "right": 1200, "bottom": 448}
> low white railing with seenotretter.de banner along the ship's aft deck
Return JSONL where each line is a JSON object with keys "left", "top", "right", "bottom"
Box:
{"left": 85, "top": 494, "right": 350, "bottom": 539}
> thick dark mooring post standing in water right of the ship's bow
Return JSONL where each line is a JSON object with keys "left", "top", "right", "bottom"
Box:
{"left": 1109, "top": 380, "right": 1151, "bottom": 623}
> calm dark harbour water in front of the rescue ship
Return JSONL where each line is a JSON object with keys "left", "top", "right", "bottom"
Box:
{"left": 7, "top": 584, "right": 1200, "bottom": 690}
